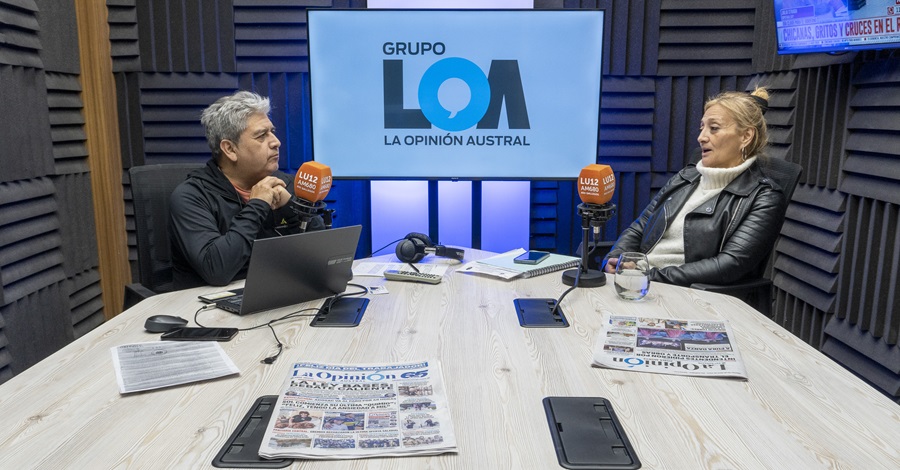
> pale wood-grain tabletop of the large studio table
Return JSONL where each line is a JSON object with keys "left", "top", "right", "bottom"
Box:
{"left": 0, "top": 250, "right": 900, "bottom": 470}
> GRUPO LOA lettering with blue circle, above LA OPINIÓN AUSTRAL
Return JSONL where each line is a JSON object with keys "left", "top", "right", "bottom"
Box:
{"left": 382, "top": 42, "right": 530, "bottom": 132}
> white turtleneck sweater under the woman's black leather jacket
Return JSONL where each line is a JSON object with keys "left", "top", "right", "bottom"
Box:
{"left": 647, "top": 157, "right": 756, "bottom": 268}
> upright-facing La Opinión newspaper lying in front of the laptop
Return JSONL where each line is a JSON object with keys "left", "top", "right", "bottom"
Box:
{"left": 259, "top": 361, "right": 457, "bottom": 459}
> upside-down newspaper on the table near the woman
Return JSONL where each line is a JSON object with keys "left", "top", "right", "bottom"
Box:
{"left": 593, "top": 315, "right": 747, "bottom": 380}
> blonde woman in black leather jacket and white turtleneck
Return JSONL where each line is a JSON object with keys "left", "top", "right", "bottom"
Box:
{"left": 603, "top": 88, "right": 788, "bottom": 286}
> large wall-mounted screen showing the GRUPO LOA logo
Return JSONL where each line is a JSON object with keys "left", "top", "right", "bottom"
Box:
{"left": 308, "top": 9, "right": 604, "bottom": 180}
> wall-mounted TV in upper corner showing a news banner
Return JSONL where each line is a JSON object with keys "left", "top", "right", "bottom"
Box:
{"left": 774, "top": 0, "right": 900, "bottom": 54}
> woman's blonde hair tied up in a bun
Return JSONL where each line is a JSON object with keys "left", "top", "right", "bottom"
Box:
{"left": 703, "top": 87, "right": 769, "bottom": 158}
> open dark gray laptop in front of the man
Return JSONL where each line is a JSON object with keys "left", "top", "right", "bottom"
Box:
{"left": 216, "top": 225, "right": 362, "bottom": 315}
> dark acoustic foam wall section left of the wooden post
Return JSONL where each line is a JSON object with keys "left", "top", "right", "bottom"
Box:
{"left": 0, "top": 0, "right": 104, "bottom": 382}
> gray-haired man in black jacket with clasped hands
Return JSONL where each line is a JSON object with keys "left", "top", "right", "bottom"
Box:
{"left": 169, "top": 91, "right": 324, "bottom": 289}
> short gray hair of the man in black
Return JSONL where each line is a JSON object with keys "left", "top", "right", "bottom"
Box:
{"left": 200, "top": 91, "right": 270, "bottom": 161}
